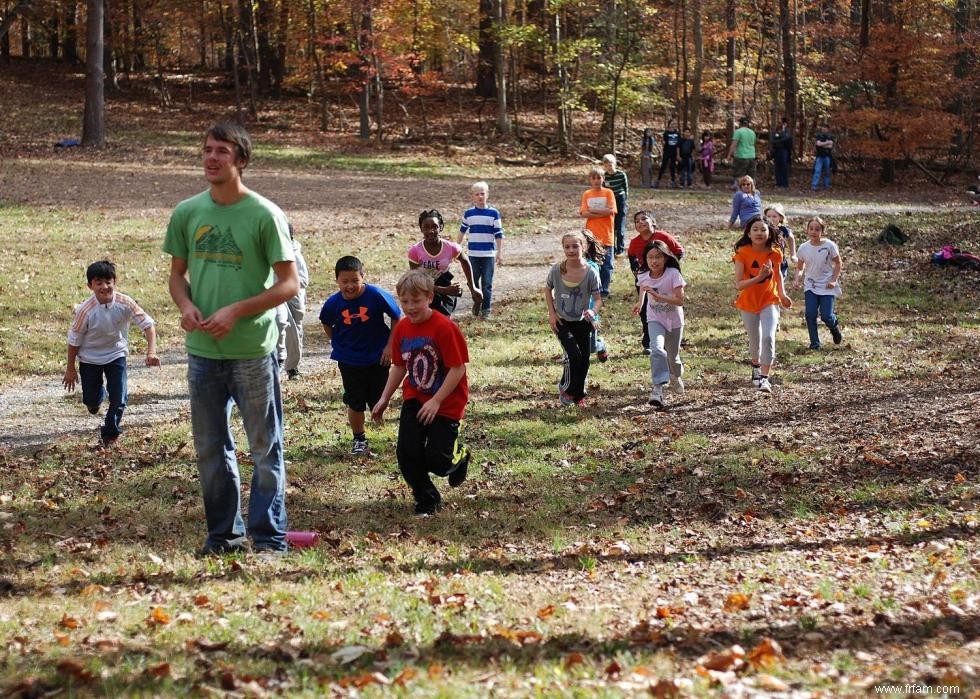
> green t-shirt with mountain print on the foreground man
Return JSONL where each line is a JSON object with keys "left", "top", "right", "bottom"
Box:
{"left": 163, "top": 191, "right": 295, "bottom": 359}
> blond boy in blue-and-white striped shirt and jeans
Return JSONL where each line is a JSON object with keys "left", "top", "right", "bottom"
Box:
{"left": 456, "top": 182, "right": 504, "bottom": 318}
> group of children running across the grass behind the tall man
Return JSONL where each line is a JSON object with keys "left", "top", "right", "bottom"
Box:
{"left": 63, "top": 174, "right": 842, "bottom": 515}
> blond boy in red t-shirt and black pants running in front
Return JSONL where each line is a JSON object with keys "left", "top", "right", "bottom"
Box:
{"left": 371, "top": 271, "right": 470, "bottom": 515}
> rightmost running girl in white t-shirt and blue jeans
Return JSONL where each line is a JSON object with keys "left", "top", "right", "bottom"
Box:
{"left": 794, "top": 216, "right": 844, "bottom": 350}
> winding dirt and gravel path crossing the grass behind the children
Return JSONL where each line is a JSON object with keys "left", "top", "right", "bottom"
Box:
{"left": 0, "top": 161, "right": 948, "bottom": 451}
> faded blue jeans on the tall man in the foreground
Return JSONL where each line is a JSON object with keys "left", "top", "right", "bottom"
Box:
{"left": 187, "top": 353, "right": 286, "bottom": 551}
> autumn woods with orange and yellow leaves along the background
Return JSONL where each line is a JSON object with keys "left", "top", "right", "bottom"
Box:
{"left": 0, "top": 0, "right": 978, "bottom": 181}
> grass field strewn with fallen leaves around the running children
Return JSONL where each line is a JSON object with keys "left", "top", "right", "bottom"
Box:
{"left": 0, "top": 137, "right": 980, "bottom": 697}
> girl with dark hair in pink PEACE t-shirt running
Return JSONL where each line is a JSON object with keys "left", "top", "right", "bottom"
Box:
{"left": 408, "top": 209, "right": 483, "bottom": 317}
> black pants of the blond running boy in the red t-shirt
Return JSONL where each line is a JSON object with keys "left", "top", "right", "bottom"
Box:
{"left": 396, "top": 398, "right": 464, "bottom": 507}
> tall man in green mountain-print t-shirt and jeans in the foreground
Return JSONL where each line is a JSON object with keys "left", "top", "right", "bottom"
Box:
{"left": 163, "top": 124, "right": 299, "bottom": 554}
